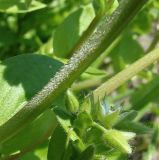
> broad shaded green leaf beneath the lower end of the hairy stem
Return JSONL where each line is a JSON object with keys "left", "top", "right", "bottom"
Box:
{"left": 0, "top": 109, "right": 57, "bottom": 155}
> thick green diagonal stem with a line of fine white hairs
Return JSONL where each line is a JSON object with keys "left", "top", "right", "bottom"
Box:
{"left": 0, "top": 0, "right": 148, "bottom": 143}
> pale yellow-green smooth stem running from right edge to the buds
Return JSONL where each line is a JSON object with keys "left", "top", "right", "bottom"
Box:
{"left": 93, "top": 48, "right": 159, "bottom": 103}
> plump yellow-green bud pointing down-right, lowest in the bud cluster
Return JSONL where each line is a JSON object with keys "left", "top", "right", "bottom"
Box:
{"left": 104, "top": 129, "right": 132, "bottom": 154}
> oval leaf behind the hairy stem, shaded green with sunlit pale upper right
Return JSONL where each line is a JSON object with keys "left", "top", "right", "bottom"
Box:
{"left": 53, "top": 4, "right": 95, "bottom": 57}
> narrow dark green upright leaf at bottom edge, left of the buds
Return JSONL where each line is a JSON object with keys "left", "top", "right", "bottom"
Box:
{"left": 48, "top": 125, "right": 68, "bottom": 160}
